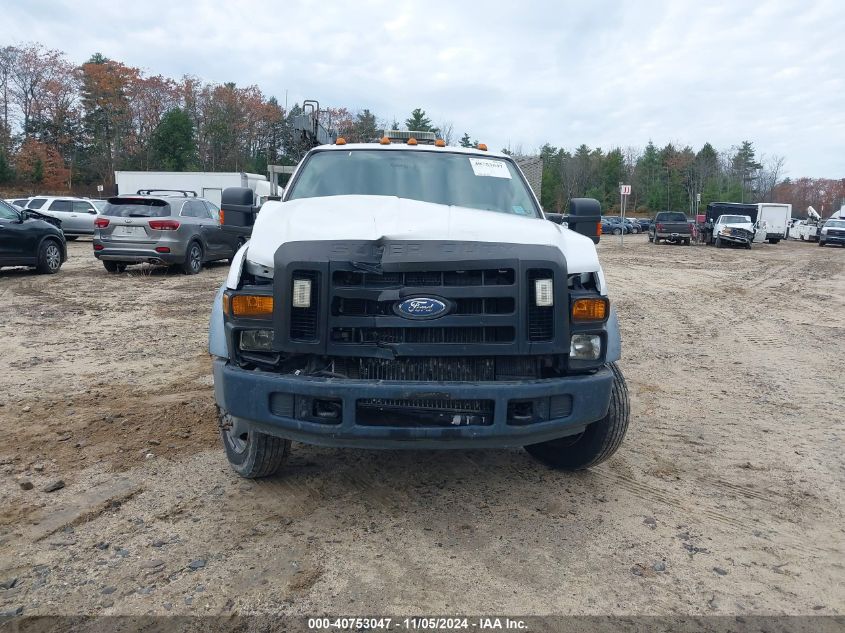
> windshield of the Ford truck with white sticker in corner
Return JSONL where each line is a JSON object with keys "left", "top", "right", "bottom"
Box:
{"left": 287, "top": 150, "right": 539, "bottom": 217}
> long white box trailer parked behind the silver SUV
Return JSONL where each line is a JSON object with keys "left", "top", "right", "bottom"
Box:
{"left": 114, "top": 171, "right": 271, "bottom": 207}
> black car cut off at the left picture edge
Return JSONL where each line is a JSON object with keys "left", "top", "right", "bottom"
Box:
{"left": 0, "top": 200, "right": 67, "bottom": 274}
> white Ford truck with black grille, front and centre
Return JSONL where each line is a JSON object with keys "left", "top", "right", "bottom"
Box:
{"left": 209, "top": 133, "right": 629, "bottom": 477}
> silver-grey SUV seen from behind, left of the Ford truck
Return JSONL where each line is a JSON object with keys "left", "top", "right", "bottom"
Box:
{"left": 94, "top": 190, "right": 244, "bottom": 275}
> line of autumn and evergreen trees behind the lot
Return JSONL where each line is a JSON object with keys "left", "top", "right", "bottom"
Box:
{"left": 0, "top": 43, "right": 845, "bottom": 214}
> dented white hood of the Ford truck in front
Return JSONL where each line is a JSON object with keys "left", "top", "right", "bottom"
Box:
{"left": 246, "top": 196, "right": 603, "bottom": 272}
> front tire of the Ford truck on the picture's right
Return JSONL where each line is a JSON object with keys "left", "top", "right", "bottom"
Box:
{"left": 525, "top": 363, "right": 631, "bottom": 470}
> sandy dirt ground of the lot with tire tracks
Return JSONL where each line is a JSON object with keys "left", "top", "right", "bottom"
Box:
{"left": 0, "top": 236, "right": 845, "bottom": 615}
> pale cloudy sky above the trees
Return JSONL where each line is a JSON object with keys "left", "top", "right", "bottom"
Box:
{"left": 0, "top": 0, "right": 845, "bottom": 178}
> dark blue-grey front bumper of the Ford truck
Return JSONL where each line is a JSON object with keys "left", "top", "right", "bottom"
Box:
{"left": 214, "top": 358, "right": 613, "bottom": 449}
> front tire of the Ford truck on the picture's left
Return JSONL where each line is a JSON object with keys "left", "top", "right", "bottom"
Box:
{"left": 218, "top": 410, "right": 290, "bottom": 479}
